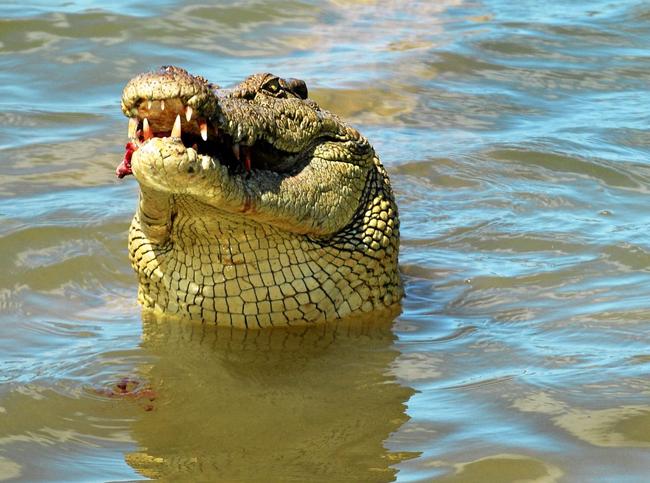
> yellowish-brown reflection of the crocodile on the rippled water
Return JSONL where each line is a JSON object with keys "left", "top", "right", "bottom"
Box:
{"left": 126, "top": 314, "right": 413, "bottom": 481}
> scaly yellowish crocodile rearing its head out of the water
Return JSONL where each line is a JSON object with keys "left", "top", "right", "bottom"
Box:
{"left": 116, "top": 66, "right": 403, "bottom": 328}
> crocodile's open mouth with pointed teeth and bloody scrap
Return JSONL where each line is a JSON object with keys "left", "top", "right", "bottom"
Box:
{"left": 115, "top": 98, "right": 295, "bottom": 178}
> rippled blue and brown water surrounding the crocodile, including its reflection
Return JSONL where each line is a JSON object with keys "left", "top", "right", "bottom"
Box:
{"left": 0, "top": 0, "right": 650, "bottom": 482}
